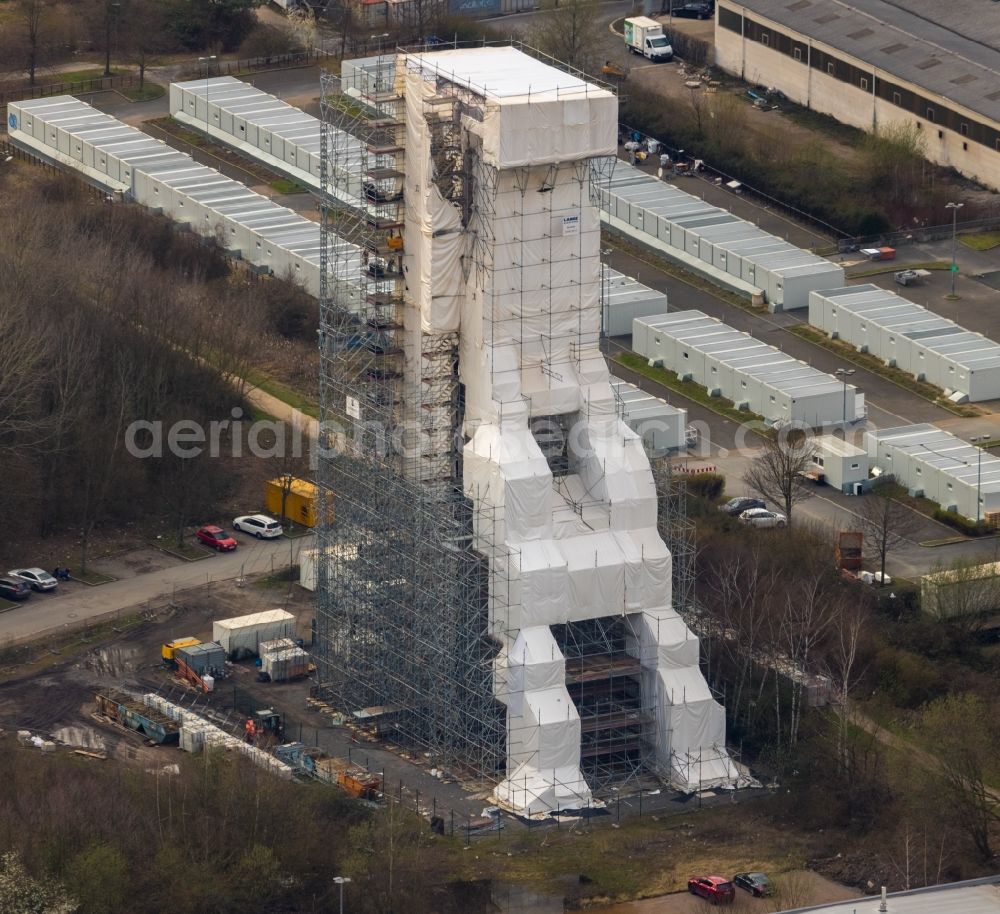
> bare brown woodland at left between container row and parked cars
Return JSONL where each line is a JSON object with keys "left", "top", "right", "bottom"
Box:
{"left": 0, "top": 167, "right": 316, "bottom": 566}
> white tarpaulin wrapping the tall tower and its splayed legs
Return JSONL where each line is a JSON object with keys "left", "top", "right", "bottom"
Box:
{"left": 400, "top": 48, "right": 725, "bottom": 815}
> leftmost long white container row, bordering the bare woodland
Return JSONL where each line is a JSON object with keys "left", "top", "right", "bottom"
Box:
{"left": 8, "top": 95, "right": 368, "bottom": 307}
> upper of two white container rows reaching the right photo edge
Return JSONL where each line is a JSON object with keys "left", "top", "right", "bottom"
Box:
{"left": 809, "top": 284, "right": 1000, "bottom": 403}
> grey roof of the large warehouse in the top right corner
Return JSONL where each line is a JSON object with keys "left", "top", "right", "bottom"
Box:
{"left": 733, "top": 0, "right": 1000, "bottom": 122}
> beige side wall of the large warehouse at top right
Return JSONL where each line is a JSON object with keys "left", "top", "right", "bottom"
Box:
{"left": 715, "top": 23, "right": 1000, "bottom": 190}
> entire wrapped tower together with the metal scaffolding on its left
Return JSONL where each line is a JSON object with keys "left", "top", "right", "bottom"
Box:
{"left": 315, "top": 47, "right": 737, "bottom": 817}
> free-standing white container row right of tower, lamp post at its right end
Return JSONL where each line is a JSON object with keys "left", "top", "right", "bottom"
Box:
{"left": 632, "top": 311, "right": 865, "bottom": 428}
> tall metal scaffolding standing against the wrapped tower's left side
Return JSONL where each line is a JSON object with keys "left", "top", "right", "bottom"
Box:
{"left": 317, "top": 62, "right": 505, "bottom": 778}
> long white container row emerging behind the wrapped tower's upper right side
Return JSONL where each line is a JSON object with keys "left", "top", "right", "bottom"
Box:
{"left": 599, "top": 162, "right": 844, "bottom": 311}
